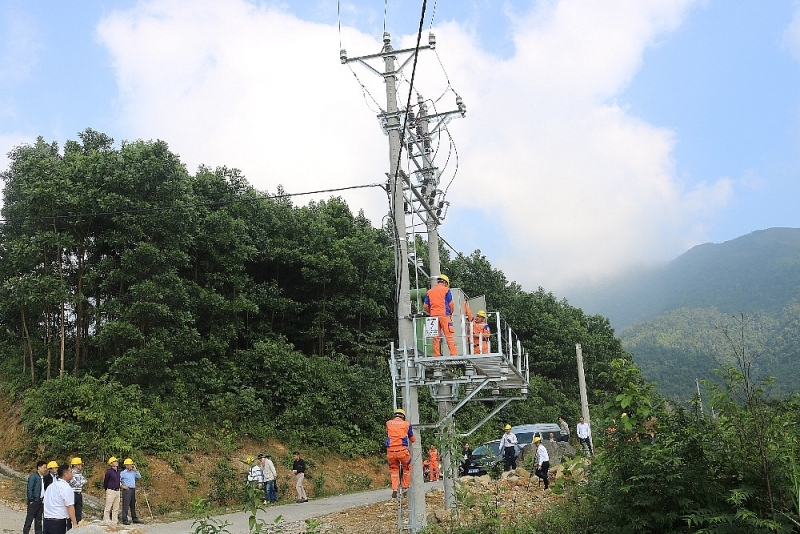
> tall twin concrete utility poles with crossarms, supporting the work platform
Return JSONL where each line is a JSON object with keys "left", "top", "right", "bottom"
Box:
{"left": 340, "top": 32, "right": 466, "bottom": 532}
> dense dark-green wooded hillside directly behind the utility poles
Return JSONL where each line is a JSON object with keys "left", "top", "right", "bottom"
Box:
{"left": 0, "top": 129, "right": 626, "bottom": 457}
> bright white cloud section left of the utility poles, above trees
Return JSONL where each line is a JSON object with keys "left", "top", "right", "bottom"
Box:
{"left": 98, "top": 0, "right": 387, "bottom": 219}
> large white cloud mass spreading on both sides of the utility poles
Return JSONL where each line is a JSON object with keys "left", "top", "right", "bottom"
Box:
{"left": 98, "top": 0, "right": 731, "bottom": 290}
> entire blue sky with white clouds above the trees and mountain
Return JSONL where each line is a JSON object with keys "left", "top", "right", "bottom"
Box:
{"left": 0, "top": 0, "right": 800, "bottom": 298}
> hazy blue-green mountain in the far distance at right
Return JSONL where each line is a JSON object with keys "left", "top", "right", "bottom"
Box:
{"left": 570, "top": 228, "right": 800, "bottom": 398}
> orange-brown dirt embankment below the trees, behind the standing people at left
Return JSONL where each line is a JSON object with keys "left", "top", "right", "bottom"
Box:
{"left": 0, "top": 395, "right": 390, "bottom": 518}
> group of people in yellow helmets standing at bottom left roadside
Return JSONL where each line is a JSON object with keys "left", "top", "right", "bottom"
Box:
{"left": 22, "top": 456, "right": 142, "bottom": 534}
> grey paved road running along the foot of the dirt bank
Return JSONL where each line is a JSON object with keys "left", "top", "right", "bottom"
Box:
{"left": 136, "top": 482, "right": 442, "bottom": 534}
